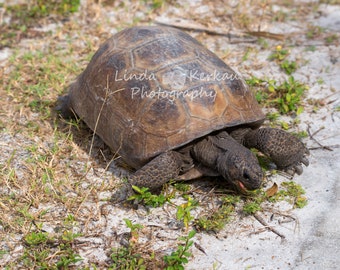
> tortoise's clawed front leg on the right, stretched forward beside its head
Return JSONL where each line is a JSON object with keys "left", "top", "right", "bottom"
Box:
{"left": 243, "top": 128, "right": 309, "bottom": 174}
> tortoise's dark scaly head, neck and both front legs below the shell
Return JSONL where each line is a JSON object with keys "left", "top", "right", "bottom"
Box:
{"left": 116, "top": 128, "right": 308, "bottom": 200}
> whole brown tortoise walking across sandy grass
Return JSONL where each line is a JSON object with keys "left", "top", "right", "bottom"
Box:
{"left": 60, "top": 26, "right": 308, "bottom": 196}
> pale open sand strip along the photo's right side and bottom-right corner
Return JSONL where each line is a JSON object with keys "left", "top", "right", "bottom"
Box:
{"left": 195, "top": 7, "right": 340, "bottom": 269}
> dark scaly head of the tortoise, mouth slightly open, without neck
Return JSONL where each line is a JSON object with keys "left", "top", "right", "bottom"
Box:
{"left": 217, "top": 147, "right": 263, "bottom": 192}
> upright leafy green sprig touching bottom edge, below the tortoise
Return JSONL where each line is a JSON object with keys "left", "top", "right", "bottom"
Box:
{"left": 163, "top": 230, "right": 196, "bottom": 270}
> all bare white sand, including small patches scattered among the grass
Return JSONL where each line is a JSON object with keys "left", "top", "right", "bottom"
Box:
{"left": 0, "top": 1, "right": 340, "bottom": 270}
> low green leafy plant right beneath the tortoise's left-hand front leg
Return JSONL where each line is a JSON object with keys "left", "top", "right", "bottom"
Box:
{"left": 128, "top": 186, "right": 170, "bottom": 207}
